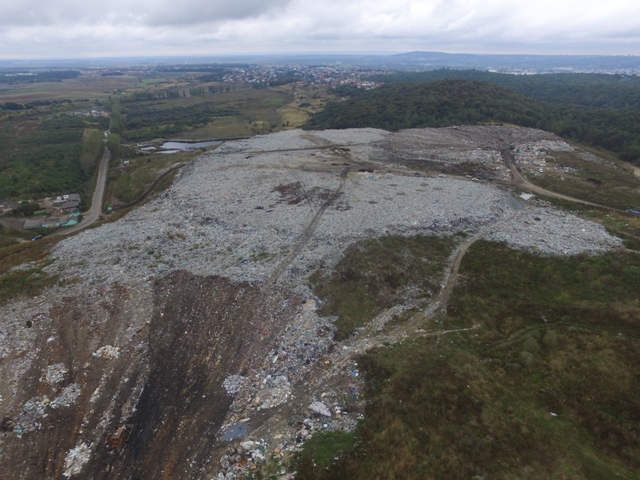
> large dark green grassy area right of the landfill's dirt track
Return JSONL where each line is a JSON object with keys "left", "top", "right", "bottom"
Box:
{"left": 298, "top": 241, "right": 640, "bottom": 480}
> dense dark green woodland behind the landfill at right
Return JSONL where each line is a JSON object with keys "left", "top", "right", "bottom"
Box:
{"left": 304, "top": 74, "right": 640, "bottom": 163}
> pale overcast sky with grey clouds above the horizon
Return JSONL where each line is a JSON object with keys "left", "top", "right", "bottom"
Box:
{"left": 0, "top": 0, "right": 640, "bottom": 59}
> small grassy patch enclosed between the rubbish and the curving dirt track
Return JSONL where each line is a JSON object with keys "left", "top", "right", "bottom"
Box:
{"left": 310, "top": 235, "right": 455, "bottom": 340}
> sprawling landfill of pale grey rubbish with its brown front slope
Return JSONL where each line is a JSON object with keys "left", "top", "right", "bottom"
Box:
{"left": 0, "top": 126, "right": 621, "bottom": 479}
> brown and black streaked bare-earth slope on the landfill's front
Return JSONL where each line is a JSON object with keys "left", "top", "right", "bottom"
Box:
{"left": 2, "top": 272, "right": 300, "bottom": 479}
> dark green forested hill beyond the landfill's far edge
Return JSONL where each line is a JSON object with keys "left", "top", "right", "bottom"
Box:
{"left": 305, "top": 75, "right": 640, "bottom": 163}
